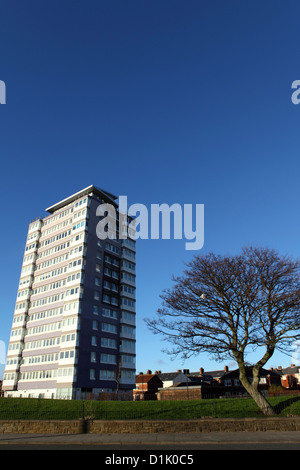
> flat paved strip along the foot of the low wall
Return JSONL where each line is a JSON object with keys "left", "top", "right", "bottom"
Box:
{"left": 0, "top": 431, "right": 300, "bottom": 450}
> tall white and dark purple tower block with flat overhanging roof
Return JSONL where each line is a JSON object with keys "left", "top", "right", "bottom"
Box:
{"left": 3, "top": 186, "right": 135, "bottom": 398}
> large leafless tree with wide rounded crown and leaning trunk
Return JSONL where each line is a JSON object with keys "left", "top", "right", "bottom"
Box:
{"left": 146, "top": 247, "right": 300, "bottom": 415}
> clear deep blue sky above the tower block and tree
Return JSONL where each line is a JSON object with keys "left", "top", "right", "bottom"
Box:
{"left": 0, "top": 0, "right": 300, "bottom": 378}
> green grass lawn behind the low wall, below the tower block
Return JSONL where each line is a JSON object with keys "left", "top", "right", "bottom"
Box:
{"left": 0, "top": 397, "right": 300, "bottom": 419}
